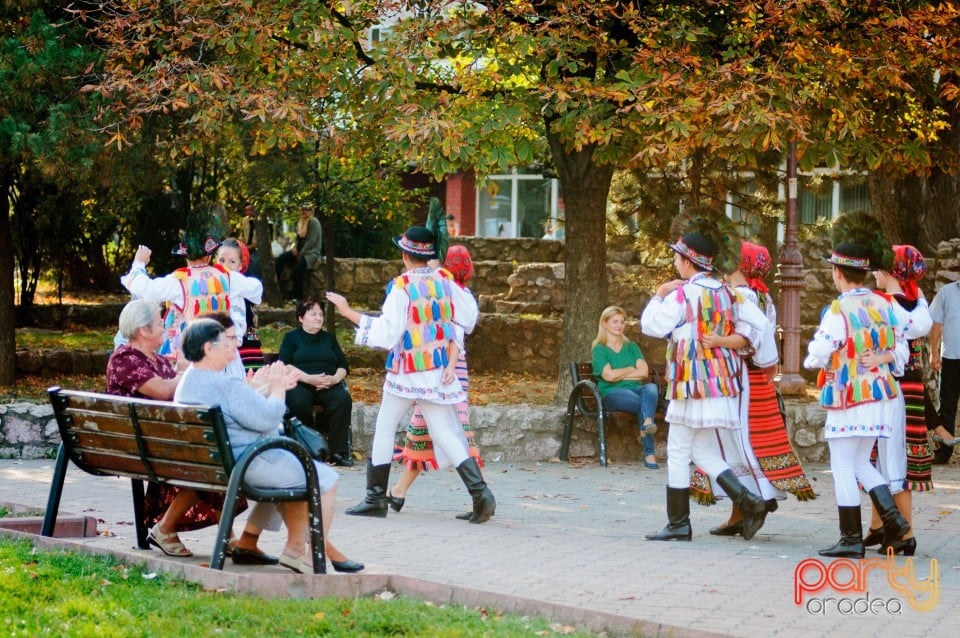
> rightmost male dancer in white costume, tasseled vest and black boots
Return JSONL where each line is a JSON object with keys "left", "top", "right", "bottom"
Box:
{"left": 803, "top": 213, "right": 910, "bottom": 558}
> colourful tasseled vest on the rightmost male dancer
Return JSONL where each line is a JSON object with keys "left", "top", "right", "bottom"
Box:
{"left": 817, "top": 294, "right": 900, "bottom": 410}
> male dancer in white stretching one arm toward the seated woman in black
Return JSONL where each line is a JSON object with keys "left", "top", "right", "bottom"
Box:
{"left": 327, "top": 226, "right": 497, "bottom": 523}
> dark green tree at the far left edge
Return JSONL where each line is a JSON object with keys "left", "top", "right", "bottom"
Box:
{"left": 0, "top": 3, "right": 102, "bottom": 384}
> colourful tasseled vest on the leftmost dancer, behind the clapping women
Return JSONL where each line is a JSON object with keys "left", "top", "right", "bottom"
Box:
{"left": 160, "top": 264, "right": 230, "bottom": 360}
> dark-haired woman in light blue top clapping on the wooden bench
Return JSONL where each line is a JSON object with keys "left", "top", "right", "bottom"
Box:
{"left": 174, "top": 319, "right": 363, "bottom": 574}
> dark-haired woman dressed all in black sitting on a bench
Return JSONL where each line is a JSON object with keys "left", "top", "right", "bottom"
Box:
{"left": 280, "top": 297, "right": 353, "bottom": 467}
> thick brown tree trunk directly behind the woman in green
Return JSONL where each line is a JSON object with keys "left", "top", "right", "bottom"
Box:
{"left": 547, "top": 131, "right": 613, "bottom": 405}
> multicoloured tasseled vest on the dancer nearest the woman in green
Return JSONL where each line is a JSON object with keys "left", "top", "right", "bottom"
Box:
{"left": 667, "top": 279, "right": 741, "bottom": 399}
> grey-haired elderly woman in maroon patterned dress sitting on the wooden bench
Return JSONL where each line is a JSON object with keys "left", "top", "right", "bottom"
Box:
{"left": 107, "top": 299, "right": 237, "bottom": 557}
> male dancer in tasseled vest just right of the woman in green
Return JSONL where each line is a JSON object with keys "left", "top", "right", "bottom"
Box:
{"left": 640, "top": 212, "right": 766, "bottom": 540}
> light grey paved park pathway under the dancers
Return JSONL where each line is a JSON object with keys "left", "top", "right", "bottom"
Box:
{"left": 0, "top": 460, "right": 960, "bottom": 638}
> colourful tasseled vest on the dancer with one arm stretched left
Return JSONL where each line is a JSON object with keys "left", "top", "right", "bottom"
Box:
{"left": 386, "top": 268, "right": 456, "bottom": 373}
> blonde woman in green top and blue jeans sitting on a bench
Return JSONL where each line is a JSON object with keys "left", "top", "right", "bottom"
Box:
{"left": 593, "top": 306, "right": 660, "bottom": 470}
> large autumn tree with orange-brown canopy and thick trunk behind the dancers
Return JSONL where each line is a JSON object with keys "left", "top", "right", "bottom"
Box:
{"left": 82, "top": 0, "right": 960, "bottom": 399}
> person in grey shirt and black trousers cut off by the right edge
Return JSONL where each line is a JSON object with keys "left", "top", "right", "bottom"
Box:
{"left": 930, "top": 281, "right": 960, "bottom": 465}
